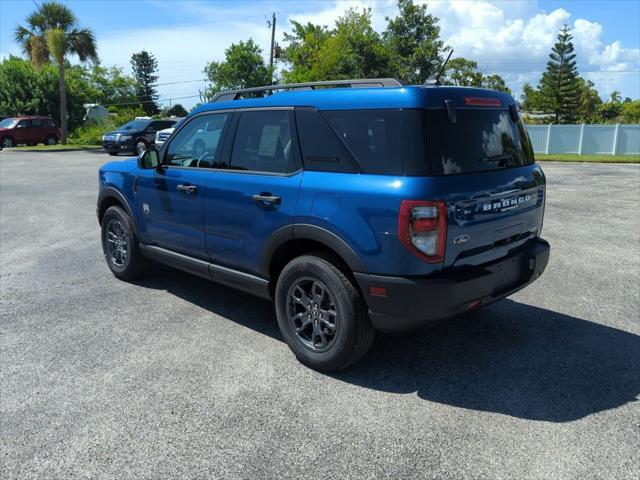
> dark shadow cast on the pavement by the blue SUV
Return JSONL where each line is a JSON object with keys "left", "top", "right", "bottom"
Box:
{"left": 132, "top": 267, "right": 640, "bottom": 422}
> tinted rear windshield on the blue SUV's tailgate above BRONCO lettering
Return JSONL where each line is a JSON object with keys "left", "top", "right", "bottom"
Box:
{"left": 427, "top": 109, "right": 534, "bottom": 175}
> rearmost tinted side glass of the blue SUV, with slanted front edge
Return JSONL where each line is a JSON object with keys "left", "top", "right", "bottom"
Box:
{"left": 323, "top": 109, "right": 402, "bottom": 175}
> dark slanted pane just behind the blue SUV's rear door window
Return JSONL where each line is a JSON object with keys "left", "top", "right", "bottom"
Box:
{"left": 296, "top": 108, "right": 358, "bottom": 173}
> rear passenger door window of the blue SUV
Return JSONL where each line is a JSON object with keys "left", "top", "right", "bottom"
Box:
{"left": 230, "top": 110, "right": 296, "bottom": 173}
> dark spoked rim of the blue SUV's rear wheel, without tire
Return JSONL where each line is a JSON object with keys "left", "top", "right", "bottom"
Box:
{"left": 287, "top": 278, "right": 339, "bottom": 352}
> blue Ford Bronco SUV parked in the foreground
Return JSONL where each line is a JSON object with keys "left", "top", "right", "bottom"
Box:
{"left": 97, "top": 79, "right": 549, "bottom": 371}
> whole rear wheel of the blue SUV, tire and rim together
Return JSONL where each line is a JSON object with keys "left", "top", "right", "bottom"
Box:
{"left": 275, "top": 253, "right": 375, "bottom": 372}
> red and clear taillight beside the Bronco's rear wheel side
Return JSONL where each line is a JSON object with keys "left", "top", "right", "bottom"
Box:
{"left": 398, "top": 200, "right": 447, "bottom": 263}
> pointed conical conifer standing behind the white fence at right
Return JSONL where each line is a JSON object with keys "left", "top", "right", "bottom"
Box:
{"left": 539, "top": 25, "right": 580, "bottom": 123}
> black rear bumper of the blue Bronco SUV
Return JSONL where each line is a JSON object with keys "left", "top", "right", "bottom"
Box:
{"left": 354, "top": 239, "right": 550, "bottom": 331}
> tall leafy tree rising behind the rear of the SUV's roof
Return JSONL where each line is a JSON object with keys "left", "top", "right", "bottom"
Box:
{"left": 382, "top": 0, "right": 444, "bottom": 84}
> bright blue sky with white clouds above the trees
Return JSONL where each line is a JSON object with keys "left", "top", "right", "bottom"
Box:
{"left": 0, "top": 0, "right": 640, "bottom": 108}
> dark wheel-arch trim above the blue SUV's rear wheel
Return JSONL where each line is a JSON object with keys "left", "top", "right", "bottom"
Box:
{"left": 260, "top": 223, "right": 366, "bottom": 278}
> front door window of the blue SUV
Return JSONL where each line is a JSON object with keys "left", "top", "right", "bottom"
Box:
{"left": 163, "top": 113, "right": 231, "bottom": 168}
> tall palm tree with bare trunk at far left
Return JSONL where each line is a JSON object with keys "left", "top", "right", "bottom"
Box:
{"left": 15, "top": 1, "right": 98, "bottom": 144}
